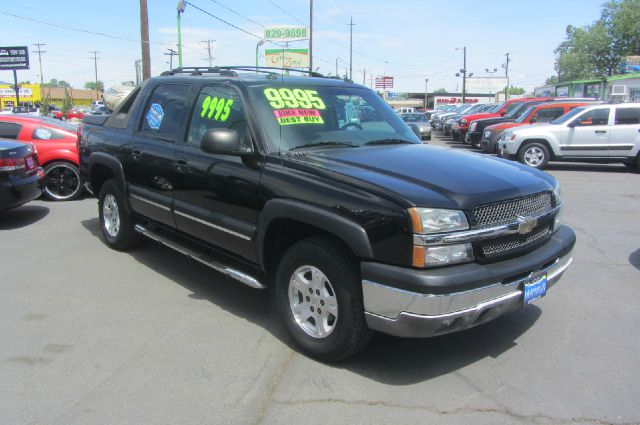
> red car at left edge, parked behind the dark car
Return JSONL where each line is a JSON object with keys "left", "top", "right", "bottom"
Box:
{"left": 0, "top": 115, "right": 83, "bottom": 201}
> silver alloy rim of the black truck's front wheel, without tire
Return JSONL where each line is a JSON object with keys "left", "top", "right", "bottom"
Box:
{"left": 289, "top": 266, "right": 338, "bottom": 338}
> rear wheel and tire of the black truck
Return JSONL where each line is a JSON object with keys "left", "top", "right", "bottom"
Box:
{"left": 98, "top": 179, "right": 140, "bottom": 251}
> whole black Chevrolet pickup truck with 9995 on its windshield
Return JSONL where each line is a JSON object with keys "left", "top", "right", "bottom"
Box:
{"left": 79, "top": 67, "right": 575, "bottom": 360}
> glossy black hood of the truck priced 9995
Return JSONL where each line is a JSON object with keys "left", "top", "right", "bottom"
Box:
{"left": 285, "top": 144, "right": 555, "bottom": 210}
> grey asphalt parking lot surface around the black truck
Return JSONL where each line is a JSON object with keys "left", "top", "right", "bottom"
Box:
{"left": 0, "top": 134, "right": 640, "bottom": 425}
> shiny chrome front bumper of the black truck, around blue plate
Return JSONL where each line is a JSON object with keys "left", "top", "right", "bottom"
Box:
{"left": 362, "top": 252, "right": 572, "bottom": 337}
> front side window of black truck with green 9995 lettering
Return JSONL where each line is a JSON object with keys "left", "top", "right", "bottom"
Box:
{"left": 187, "top": 86, "right": 247, "bottom": 146}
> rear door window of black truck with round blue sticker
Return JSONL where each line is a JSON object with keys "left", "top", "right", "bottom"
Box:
{"left": 140, "top": 84, "right": 191, "bottom": 142}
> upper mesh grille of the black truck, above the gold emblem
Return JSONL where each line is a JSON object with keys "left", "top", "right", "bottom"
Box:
{"left": 473, "top": 192, "right": 552, "bottom": 227}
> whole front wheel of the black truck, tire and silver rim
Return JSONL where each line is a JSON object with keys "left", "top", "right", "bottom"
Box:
{"left": 274, "top": 237, "right": 372, "bottom": 361}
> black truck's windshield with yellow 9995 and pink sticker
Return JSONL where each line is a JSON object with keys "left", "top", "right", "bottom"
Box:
{"left": 251, "top": 84, "right": 420, "bottom": 152}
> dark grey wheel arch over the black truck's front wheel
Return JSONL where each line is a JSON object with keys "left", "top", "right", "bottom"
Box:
{"left": 256, "top": 199, "right": 373, "bottom": 273}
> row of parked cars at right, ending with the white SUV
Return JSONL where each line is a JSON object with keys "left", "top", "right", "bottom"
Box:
{"left": 430, "top": 98, "right": 640, "bottom": 169}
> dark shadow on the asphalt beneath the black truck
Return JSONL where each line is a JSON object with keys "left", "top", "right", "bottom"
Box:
{"left": 82, "top": 218, "right": 541, "bottom": 385}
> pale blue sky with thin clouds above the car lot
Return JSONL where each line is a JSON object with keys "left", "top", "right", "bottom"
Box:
{"left": 0, "top": 0, "right": 604, "bottom": 92}
